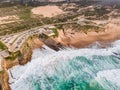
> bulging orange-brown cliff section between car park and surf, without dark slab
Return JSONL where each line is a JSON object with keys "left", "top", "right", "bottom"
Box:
{"left": 18, "top": 37, "right": 43, "bottom": 65}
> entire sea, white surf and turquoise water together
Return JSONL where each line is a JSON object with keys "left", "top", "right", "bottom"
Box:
{"left": 8, "top": 41, "right": 120, "bottom": 90}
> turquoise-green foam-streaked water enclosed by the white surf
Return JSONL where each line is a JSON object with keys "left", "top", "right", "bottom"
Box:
{"left": 27, "top": 55, "right": 120, "bottom": 90}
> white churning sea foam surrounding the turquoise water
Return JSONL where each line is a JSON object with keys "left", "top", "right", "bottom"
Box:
{"left": 8, "top": 41, "right": 120, "bottom": 90}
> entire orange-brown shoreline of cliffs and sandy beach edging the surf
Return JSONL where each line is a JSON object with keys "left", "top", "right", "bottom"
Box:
{"left": 2, "top": 20, "right": 120, "bottom": 90}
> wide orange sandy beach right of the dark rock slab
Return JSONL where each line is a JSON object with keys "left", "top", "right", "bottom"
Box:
{"left": 56, "top": 18, "right": 120, "bottom": 48}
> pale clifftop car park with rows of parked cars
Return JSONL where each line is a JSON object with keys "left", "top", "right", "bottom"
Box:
{"left": 1, "top": 28, "right": 50, "bottom": 51}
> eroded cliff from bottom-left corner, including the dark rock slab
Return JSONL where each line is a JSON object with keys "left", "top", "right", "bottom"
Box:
{"left": 0, "top": 36, "right": 65, "bottom": 90}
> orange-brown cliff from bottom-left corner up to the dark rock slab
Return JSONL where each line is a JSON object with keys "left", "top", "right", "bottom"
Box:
{"left": 0, "top": 37, "right": 43, "bottom": 90}
